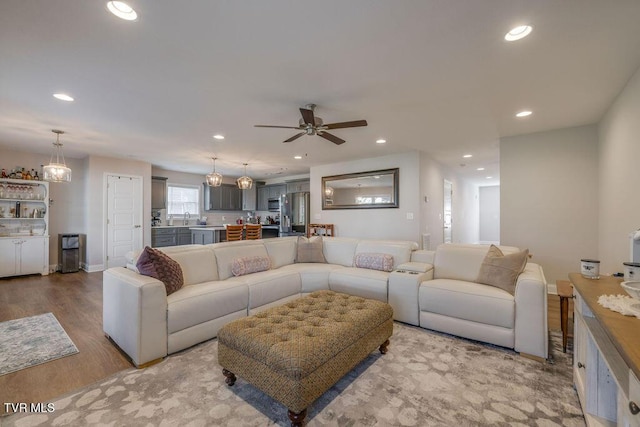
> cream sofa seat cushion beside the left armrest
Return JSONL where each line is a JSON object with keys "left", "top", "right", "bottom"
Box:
{"left": 167, "top": 280, "right": 249, "bottom": 334}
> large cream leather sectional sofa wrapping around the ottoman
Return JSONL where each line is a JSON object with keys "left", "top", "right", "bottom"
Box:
{"left": 103, "top": 237, "right": 547, "bottom": 366}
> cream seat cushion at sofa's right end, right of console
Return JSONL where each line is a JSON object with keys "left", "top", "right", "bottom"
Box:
{"left": 418, "top": 279, "right": 515, "bottom": 329}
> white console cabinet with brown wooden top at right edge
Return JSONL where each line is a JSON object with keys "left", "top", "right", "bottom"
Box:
{"left": 569, "top": 273, "right": 640, "bottom": 427}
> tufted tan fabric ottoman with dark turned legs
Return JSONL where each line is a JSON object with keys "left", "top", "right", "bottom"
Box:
{"left": 218, "top": 291, "right": 393, "bottom": 426}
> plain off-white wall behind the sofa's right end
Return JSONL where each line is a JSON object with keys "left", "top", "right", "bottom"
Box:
{"left": 500, "top": 125, "right": 598, "bottom": 283}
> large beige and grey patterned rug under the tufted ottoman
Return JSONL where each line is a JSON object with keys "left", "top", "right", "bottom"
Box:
{"left": 2, "top": 323, "right": 584, "bottom": 427}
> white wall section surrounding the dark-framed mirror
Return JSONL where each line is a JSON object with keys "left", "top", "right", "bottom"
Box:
{"left": 310, "top": 151, "right": 421, "bottom": 242}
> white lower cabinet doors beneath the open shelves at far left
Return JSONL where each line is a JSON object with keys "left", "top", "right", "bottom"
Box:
{"left": 0, "top": 236, "right": 49, "bottom": 277}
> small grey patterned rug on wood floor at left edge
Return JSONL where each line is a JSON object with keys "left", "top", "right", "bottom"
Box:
{"left": 0, "top": 313, "right": 78, "bottom": 375}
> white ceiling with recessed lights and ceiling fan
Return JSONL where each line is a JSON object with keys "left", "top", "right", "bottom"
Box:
{"left": 0, "top": 0, "right": 640, "bottom": 184}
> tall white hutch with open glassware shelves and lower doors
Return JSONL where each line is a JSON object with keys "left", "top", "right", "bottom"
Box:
{"left": 0, "top": 179, "right": 49, "bottom": 277}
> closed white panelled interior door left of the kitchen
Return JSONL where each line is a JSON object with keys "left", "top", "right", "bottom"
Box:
{"left": 105, "top": 175, "right": 142, "bottom": 268}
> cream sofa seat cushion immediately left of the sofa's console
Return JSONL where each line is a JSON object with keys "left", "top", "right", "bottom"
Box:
{"left": 329, "top": 267, "right": 390, "bottom": 302}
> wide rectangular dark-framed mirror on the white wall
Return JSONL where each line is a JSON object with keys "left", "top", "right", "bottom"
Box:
{"left": 322, "top": 168, "right": 400, "bottom": 209}
